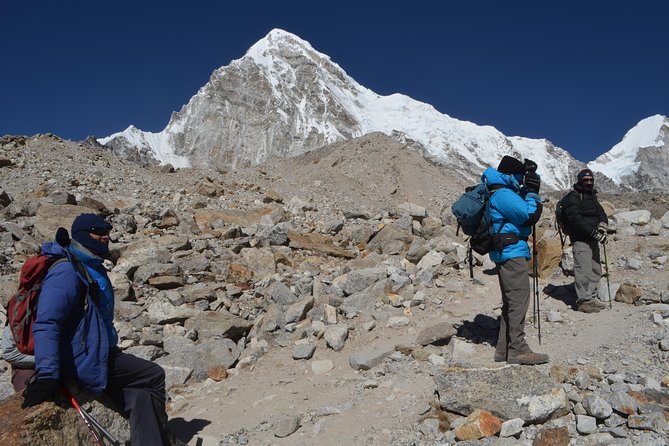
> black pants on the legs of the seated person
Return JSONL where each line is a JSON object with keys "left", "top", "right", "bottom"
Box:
{"left": 105, "top": 350, "right": 169, "bottom": 446}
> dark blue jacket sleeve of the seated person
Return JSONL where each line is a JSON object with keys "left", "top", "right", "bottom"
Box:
{"left": 33, "top": 262, "right": 80, "bottom": 379}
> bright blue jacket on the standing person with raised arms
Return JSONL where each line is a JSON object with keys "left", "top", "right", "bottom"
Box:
{"left": 481, "top": 167, "right": 543, "bottom": 263}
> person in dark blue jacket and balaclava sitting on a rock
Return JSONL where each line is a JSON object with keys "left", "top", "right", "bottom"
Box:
{"left": 23, "top": 214, "right": 171, "bottom": 446}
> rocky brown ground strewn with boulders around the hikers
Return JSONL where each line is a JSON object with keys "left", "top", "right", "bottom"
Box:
{"left": 0, "top": 134, "right": 669, "bottom": 445}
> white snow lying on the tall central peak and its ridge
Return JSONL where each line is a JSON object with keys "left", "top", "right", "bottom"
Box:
{"left": 99, "top": 29, "right": 570, "bottom": 189}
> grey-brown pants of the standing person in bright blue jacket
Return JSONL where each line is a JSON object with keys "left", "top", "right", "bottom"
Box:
{"left": 495, "top": 257, "right": 531, "bottom": 358}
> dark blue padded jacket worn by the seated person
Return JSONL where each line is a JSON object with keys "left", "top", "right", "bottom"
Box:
{"left": 33, "top": 242, "right": 113, "bottom": 394}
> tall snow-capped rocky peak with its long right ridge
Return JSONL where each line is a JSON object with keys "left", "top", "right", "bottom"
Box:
{"left": 99, "top": 29, "right": 584, "bottom": 190}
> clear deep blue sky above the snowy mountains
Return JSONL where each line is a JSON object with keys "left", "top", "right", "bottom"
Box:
{"left": 0, "top": 0, "right": 669, "bottom": 161}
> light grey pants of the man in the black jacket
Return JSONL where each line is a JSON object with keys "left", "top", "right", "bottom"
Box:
{"left": 572, "top": 240, "right": 602, "bottom": 305}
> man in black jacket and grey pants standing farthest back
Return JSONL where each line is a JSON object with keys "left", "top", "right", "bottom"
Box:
{"left": 564, "top": 169, "right": 609, "bottom": 313}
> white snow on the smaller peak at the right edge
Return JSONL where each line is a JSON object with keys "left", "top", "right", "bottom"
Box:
{"left": 588, "top": 115, "right": 669, "bottom": 185}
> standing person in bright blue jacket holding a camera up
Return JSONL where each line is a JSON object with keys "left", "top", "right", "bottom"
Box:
{"left": 482, "top": 156, "right": 548, "bottom": 365}
